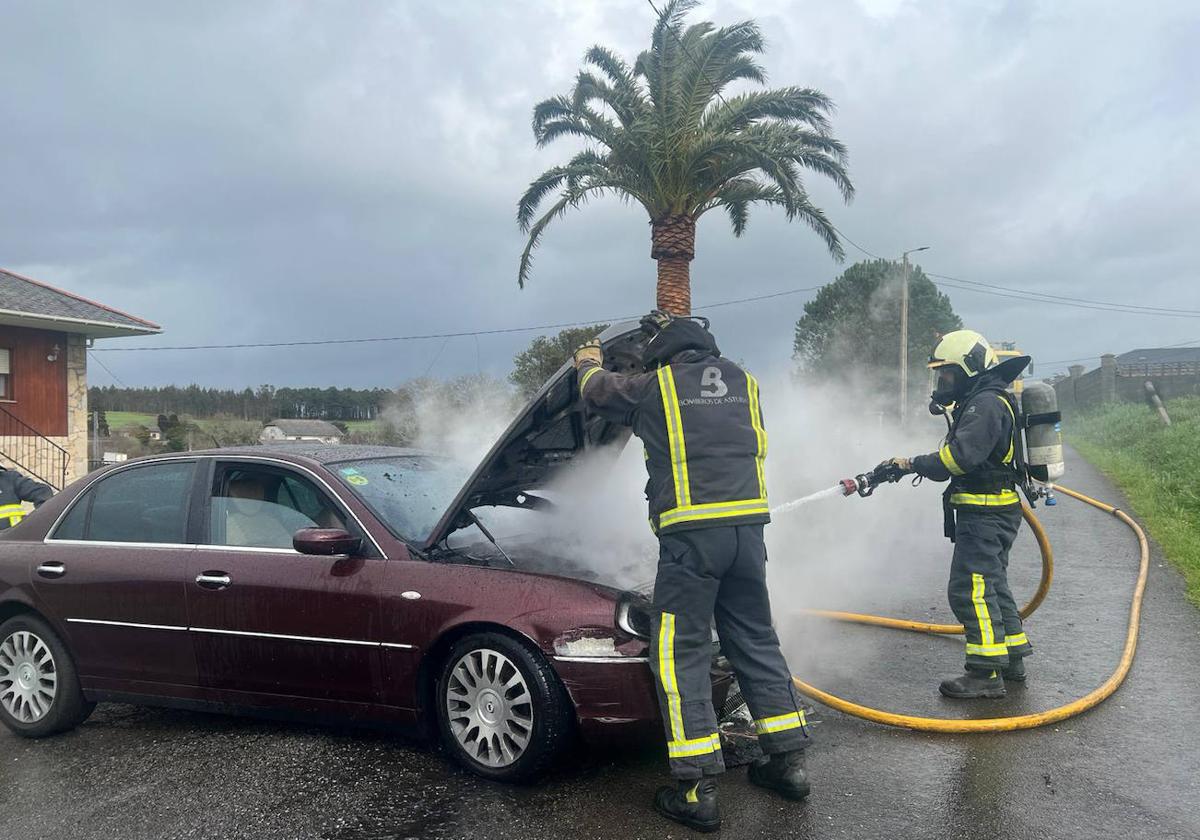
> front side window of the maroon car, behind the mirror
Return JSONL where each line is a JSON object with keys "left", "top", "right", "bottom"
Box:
{"left": 209, "top": 464, "right": 346, "bottom": 548}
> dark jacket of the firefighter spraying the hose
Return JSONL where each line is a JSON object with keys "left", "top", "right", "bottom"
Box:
{"left": 912, "top": 374, "right": 1020, "bottom": 510}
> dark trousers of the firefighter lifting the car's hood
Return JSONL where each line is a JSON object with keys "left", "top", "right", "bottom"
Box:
{"left": 650, "top": 524, "right": 809, "bottom": 779}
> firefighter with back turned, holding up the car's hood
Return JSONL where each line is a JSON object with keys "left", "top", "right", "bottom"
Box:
{"left": 575, "top": 312, "right": 809, "bottom": 830}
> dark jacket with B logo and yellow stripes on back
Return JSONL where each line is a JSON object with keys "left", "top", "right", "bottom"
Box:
{"left": 580, "top": 350, "right": 770, "bottom": 534}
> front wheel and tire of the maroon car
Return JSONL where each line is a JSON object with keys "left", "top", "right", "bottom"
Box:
{"left": 434, "top": 632, "right": 575, "bottom": 782}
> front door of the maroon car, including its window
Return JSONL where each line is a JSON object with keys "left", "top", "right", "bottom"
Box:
{"left": 187, "top": 458, "right": 385, "bottom": 706}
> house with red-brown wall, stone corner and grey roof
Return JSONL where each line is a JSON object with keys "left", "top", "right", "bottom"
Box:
{"left": 0, "top": 269, "right": 162, "bottom": 490}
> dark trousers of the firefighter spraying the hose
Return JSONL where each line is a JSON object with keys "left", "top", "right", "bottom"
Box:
{"left": 947, "top": 505, "right": 1033, "bottom": 670}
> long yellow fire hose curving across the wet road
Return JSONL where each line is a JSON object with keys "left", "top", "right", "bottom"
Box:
{"left": 792, "top": 485, "right": 1150, "bottom": 732}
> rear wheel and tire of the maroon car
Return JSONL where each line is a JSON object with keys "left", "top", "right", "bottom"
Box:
{"left": 0, "top": 614, "right": 96, "bottom": 738}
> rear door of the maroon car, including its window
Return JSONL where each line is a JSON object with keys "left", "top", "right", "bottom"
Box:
{"left": 31, "top": 458, "right": 198, "bottom": 694}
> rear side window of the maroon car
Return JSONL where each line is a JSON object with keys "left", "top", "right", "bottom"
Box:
{"left": 53, "top": 461, "right": 194, "bottom": 544}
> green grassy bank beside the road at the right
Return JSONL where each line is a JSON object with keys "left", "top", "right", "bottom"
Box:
{"left": 1066, "top": 397, "right": 1200, "bottom": 606}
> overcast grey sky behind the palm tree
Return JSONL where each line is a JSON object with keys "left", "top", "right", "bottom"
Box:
{"left": 0, "top": 0, "right": 1200, "bottom": 386}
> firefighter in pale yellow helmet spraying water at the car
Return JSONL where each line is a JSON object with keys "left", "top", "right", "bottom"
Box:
{"left": 890, "top": 330, "right": 1033, "bottom": 700}
